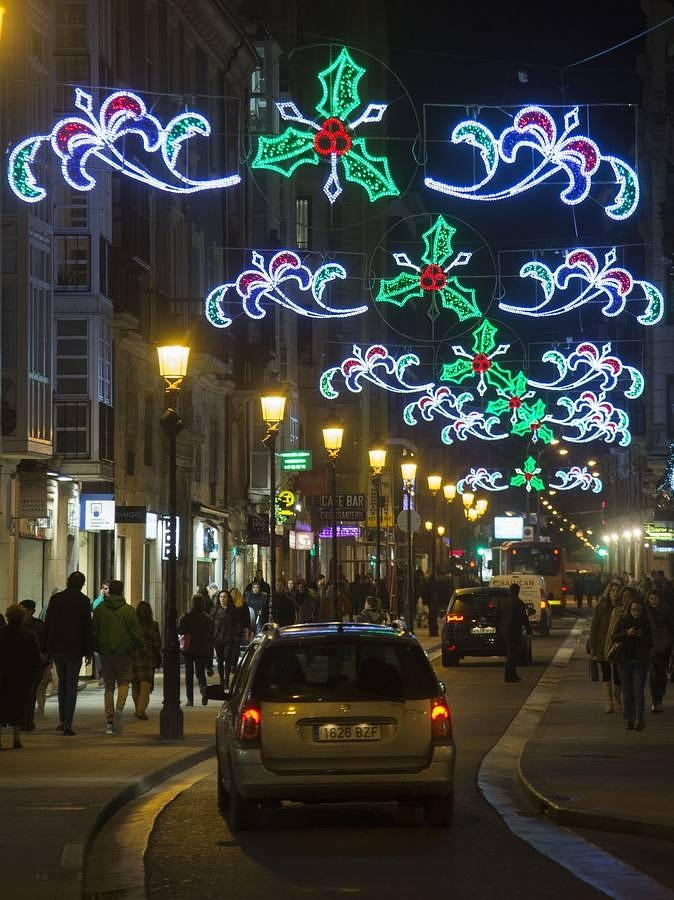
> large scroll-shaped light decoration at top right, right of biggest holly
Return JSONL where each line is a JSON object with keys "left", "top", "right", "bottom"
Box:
{"left": 424, "top": 106, "right": 639, "bottom": 220}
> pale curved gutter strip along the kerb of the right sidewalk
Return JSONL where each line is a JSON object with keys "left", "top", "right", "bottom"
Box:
{"left": 478, "top": 622, "right": 674, "bottom": 900}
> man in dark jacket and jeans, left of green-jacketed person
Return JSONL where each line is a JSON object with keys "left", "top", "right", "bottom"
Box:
{"left": 44, "top": 572, "right": 93, "bottom": 735}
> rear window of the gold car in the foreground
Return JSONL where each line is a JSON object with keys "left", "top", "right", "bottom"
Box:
{"left": 253, "top": 640, "right": 438, "bottom": 702}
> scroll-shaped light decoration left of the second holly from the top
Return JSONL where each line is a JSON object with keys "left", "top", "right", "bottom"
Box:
{"left": 205, "top": 250, "right": 367, "bottom": 328}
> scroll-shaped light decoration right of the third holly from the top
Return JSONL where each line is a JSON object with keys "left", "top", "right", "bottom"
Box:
{"left": 527, "top": 341, "right": 644, "bottom": 400}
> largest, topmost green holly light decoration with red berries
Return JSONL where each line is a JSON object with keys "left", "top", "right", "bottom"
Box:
{"left": 251, "top": 47, "right": 400, "bottom": 203}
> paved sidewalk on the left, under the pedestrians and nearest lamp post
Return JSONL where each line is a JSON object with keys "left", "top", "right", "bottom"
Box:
{"left": 0, "top": 676, "right": 215, "bottom": 900}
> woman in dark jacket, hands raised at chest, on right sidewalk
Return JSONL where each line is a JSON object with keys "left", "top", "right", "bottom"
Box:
{"left": 611, "top": 596, "right": 653, "bottom": 731}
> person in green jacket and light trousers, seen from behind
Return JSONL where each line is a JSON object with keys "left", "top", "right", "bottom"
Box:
{"left": 94, "top": 580, "right": 144, "bottom": 734}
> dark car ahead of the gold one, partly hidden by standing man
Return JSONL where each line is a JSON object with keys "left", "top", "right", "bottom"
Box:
{"left": 442, "top": 585, "right": 532, "bottom": 666}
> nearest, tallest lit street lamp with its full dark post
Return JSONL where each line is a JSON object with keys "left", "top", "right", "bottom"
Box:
{"left": 157, "top": 344, "right": 190, "bottom": 741}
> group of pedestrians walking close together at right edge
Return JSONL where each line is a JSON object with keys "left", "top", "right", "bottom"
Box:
{"left": 579, "top": 571, "right": 674, "bottom": 731}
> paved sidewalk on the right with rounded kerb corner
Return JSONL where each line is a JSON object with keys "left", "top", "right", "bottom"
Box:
{"left": 520, "top": 619, "right": 674, "bottom": 840}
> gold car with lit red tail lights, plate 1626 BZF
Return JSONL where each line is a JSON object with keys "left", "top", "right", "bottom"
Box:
{"left": 216, "top": 623, "right": 455, "bottom": 829}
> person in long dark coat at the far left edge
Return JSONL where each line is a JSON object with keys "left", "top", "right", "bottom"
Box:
{"left": 0, "top": 604, "right": 42, "bottom": 750}
